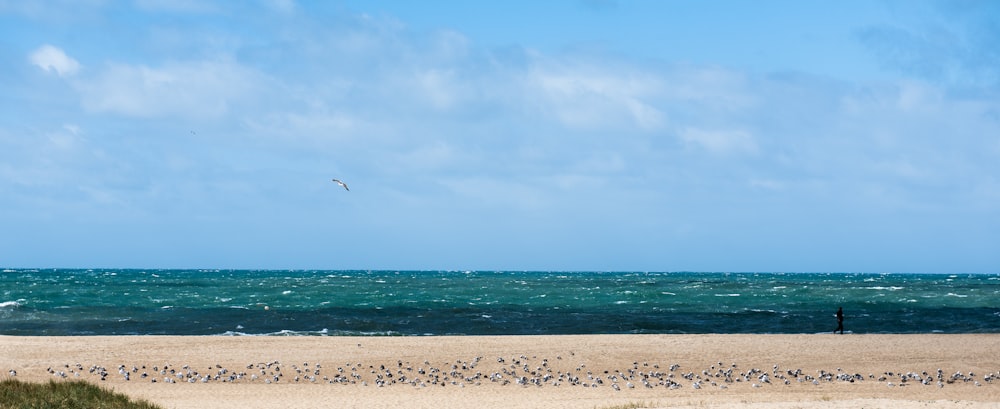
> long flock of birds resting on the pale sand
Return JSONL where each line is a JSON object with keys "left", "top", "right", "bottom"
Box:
{"left": 9, "top": 355, "right": 1000, "bottom": 391}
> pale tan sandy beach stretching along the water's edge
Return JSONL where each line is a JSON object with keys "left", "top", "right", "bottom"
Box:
{"left": 0, "top": 334, "right": 1000, "bottom": 409}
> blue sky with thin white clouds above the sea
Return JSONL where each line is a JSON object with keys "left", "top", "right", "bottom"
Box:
{"left": 0, "top": 0, "right": 1000, "bottom": 273}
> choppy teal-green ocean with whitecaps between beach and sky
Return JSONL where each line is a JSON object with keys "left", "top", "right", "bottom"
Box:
{"left": 0, "top": 269, "right": 1000, "bottom": 336}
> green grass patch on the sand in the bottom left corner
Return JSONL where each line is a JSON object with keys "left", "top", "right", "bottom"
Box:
{"left": 0, "top": 379, "right": 161, "bottom": 409}
